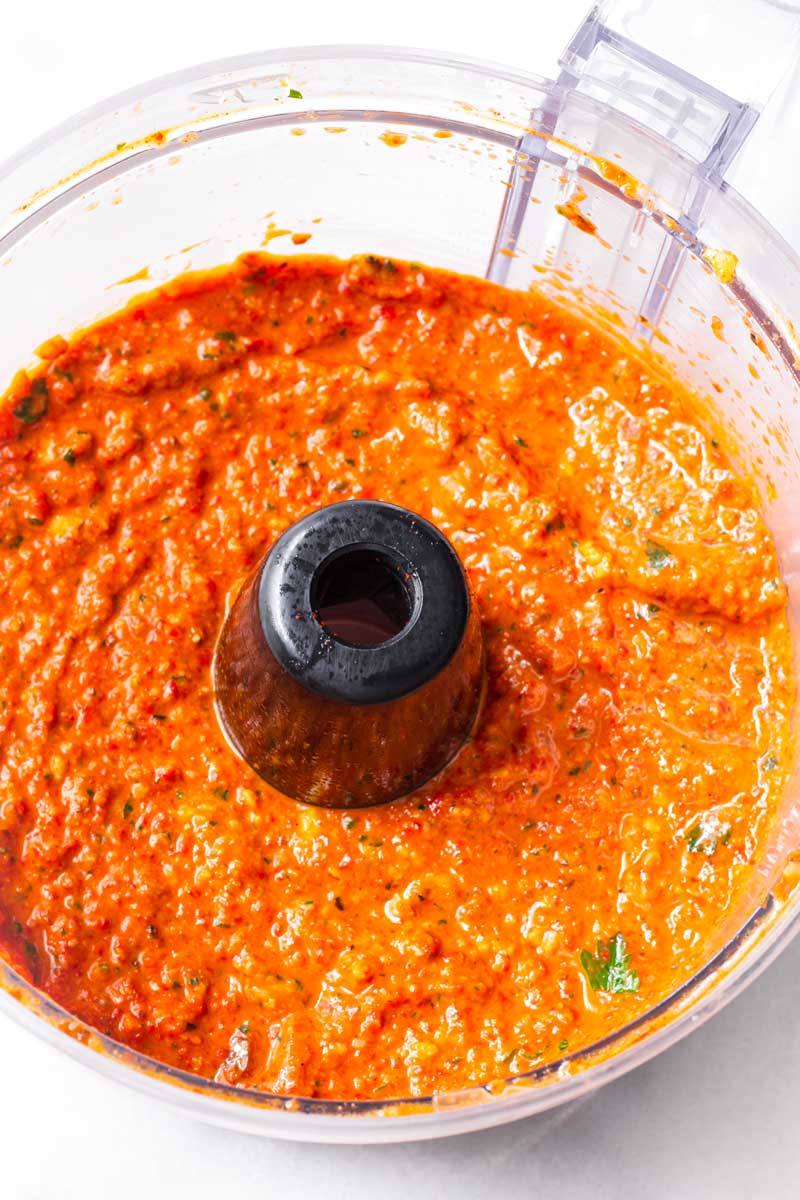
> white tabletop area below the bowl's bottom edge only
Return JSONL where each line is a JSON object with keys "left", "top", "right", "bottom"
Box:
{"left": 0, "top": 940, "right": 800, "bottom": 1200}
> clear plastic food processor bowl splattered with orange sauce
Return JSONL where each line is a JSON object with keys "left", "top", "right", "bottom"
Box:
{"left": 0, "top": 35, "right": 800, "bottom": 1142}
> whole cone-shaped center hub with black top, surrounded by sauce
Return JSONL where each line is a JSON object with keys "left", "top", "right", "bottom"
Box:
{"left": 212, "top": 500, "right": 483, "bottom": 809}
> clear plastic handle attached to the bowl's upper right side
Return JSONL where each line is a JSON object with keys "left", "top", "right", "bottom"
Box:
{"left": 486, "top": 0, "right": 800, "bottom": 328}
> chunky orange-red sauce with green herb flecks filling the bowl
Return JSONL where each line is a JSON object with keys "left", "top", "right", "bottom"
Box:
{"left": 0, "top": 256, "right": 793, "bottom": 1098}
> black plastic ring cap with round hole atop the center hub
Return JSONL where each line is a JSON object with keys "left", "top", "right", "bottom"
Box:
{"left": 258, "top": 500, "right": 470, "bottom": 704}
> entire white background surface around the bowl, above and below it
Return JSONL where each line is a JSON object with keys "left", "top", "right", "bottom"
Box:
{"left": 0, "top": 0, "right": 800, "bottom": 1200}
